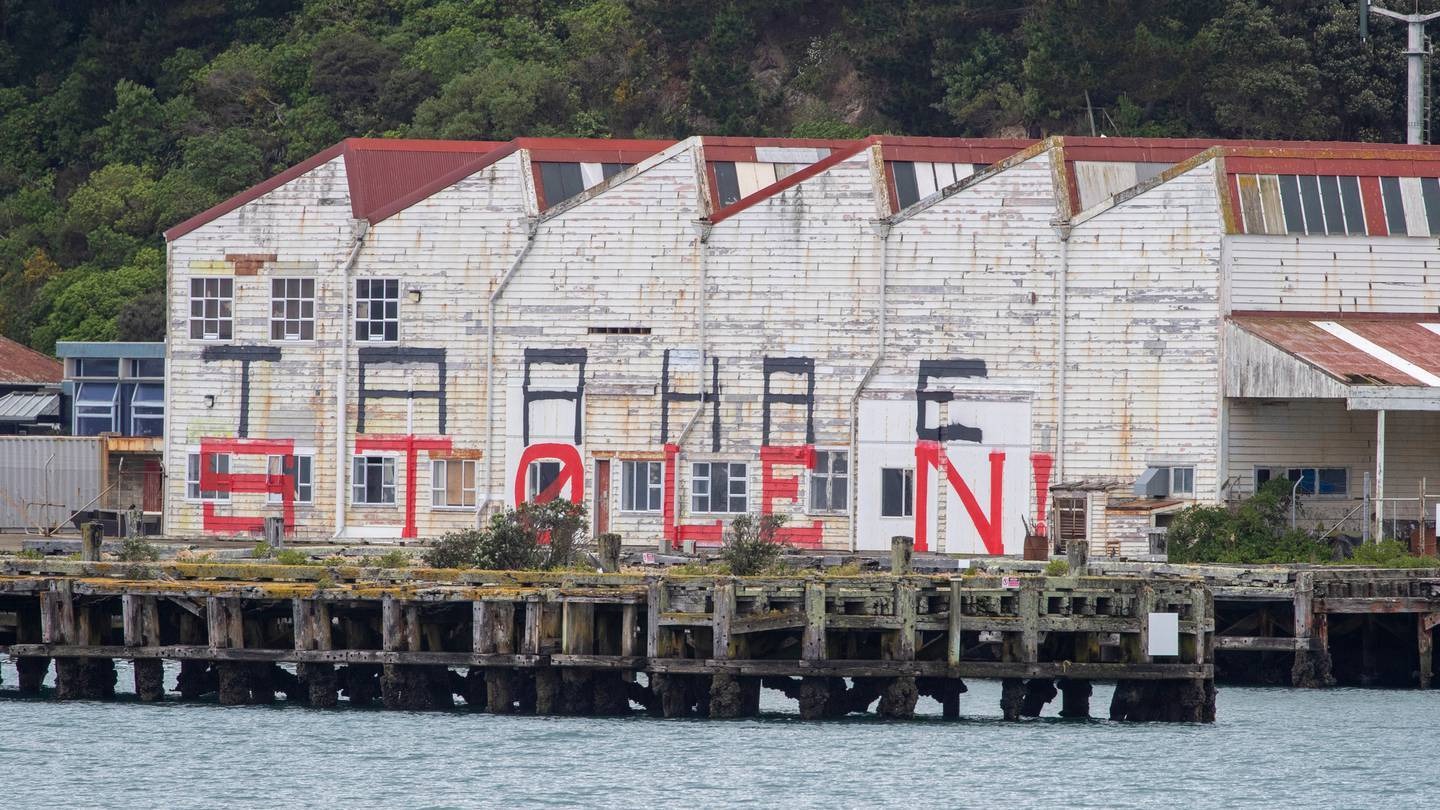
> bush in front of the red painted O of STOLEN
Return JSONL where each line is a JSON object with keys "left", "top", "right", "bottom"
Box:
{"left": 423, "top": 499, "right": 585, "bottom": 571}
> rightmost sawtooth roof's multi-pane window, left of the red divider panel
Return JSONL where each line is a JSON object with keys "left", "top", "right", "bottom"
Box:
{"left": 1236, "top": 174, "right": 1365, "bottom": 236}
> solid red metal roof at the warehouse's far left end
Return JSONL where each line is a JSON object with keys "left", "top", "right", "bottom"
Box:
{"left": 166, "top": 138, "right": 504, "bottom": 241}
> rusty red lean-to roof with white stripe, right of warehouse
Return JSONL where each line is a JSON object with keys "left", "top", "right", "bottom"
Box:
{"left": 1230, "top": 313, "right": 1440, "bottom": 388}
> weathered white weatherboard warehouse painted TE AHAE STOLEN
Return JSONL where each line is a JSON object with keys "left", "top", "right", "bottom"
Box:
{"left": 167, "top": 138, "right": 1440, "bottom": 555}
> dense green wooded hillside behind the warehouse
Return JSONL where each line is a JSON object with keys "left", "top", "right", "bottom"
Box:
{"left": 0, "top": 0, "right": 1433, "bottom": 350}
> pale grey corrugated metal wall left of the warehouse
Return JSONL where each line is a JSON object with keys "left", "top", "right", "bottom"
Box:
{"left": 0, "top": 435, "right": 102, "bottom": 530}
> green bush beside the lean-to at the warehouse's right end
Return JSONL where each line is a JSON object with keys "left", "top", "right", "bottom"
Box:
{"left": 1166, "top": 480, "right": 1331, "bottom": 564}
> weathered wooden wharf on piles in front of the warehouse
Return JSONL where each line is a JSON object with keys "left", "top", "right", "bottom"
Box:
{"left": 0, "top": 561, "right": 1215, "bottom": 722}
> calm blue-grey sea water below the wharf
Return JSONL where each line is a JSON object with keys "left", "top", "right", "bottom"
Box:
{"left": 0, "top": 659, "right": 1440, "bottom": 810}
